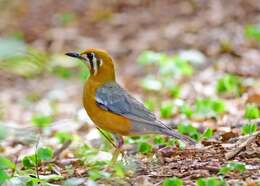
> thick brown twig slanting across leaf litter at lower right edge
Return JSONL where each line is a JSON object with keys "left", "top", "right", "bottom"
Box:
{"left": 225, "top": 131, "right": 260, "bottom": 160}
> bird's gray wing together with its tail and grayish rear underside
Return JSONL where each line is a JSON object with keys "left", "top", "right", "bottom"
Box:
{"left": 96, "top": 82, "right": 195, "bottom": 145}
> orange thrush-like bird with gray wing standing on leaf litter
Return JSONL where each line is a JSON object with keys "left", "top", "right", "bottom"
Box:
{"left": 66, "top": 48, "right": 196, "bottom": 162}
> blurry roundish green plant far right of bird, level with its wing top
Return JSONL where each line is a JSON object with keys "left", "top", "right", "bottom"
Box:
{"left": 216, "top": 74, "right": 241, "bottom": 96}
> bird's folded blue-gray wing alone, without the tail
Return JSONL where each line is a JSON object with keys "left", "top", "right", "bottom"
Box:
{"left": 96, "top": 82, "right": 156, "bottom": 122}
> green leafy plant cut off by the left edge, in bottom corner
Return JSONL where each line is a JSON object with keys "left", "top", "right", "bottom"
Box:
{"left": 0, "top": 156, "right": 15, "bottom": 185}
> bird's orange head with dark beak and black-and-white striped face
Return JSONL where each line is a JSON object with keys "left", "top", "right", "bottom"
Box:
{"left": 66, "top": 48, "right": 115, "bottom": 81}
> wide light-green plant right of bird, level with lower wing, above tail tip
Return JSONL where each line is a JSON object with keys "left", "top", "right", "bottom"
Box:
{"left": 194, "top": 98, "right": 225, "bottom": 117}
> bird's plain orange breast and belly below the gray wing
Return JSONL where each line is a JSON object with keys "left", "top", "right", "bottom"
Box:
{"left": 83, "top": 80, "right": 131, "bottom": 135}
